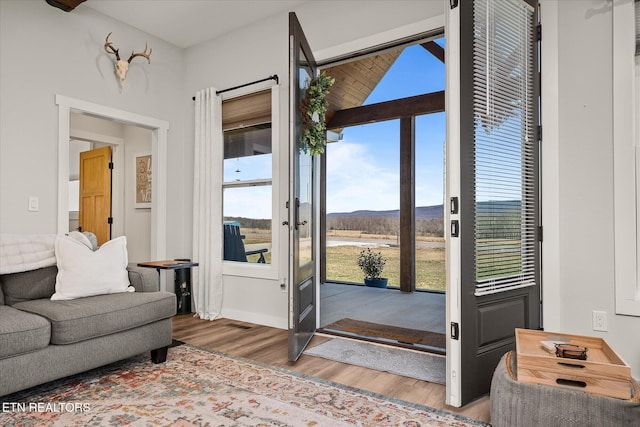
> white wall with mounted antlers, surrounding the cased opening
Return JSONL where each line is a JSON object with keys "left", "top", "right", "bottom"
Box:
{"left": 0, "top": 0, "right": 190, "bottom": 257}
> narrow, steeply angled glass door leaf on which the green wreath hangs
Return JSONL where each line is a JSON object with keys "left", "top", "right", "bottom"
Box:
{"left": 289, "top": 12, "right": 317, "bottom": 361}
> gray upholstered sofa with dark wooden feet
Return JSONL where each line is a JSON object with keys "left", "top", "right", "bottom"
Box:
{"left": 0, "top": 265, "right": 176, "bottom": 396}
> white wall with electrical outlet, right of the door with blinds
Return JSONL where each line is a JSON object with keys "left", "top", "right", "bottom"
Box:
{"left": 542, "top": 0, "right": 640, "bottom": 378}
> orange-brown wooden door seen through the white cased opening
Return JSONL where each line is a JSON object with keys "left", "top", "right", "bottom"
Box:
{"left": 78, "top": 146, "right": 112, "bottom": 245}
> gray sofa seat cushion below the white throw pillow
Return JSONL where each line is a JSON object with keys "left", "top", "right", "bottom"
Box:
{"left": 14, "top": 292, "right": 176, "bottom": 344}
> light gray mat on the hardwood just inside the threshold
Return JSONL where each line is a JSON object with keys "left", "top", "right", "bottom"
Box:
{"left": 304, "top": 338, "right": 447, "bottom": 384}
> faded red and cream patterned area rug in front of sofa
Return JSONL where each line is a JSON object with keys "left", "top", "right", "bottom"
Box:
{"left": 0, "top": 345, "right": 487, "bottom": 427}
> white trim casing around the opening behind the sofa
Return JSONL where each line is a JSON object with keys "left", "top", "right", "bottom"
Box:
{"left": 55, "top": 94, "right": 169, "bottom": 289}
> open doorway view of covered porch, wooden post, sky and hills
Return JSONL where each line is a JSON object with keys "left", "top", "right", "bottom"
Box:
{"left": 319, "top": 33, "right": 446, "bottom": 353}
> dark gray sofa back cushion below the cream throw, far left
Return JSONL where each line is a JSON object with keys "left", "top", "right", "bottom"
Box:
{"left": 0, "top": 265, "right": 58, "bottom": 305}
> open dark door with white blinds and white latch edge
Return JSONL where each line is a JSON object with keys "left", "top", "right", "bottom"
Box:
{"left": 445, "top": 0, "right": 541, "bottom": 406}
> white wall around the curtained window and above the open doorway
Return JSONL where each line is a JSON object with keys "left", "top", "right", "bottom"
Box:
{"left": 183, "top": 0, "right": 444, "bottom": 328}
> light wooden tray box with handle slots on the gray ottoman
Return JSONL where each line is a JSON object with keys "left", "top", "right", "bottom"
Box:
{"left": 515, "top": 329, "right": 632, "bottom": 399}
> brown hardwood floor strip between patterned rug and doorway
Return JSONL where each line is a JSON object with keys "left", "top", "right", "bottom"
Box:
{"left": 173, "top": 314, "right": 489, "bottom": 421}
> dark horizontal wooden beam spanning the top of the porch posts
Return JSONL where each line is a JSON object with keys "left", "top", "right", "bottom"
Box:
{"left": 327, "top": 91, "right": 444, "bottom": 129}
